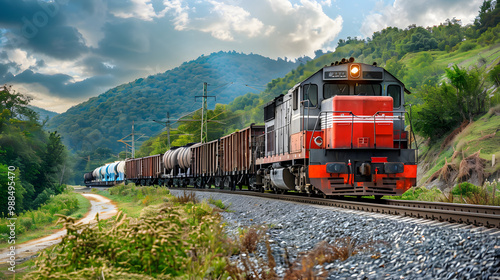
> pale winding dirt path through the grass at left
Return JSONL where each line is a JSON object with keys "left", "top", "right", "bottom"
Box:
{"left": 0, "top": 193, "right": 118, "bottom": 264}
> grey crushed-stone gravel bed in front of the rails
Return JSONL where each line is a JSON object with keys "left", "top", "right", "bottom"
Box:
{"left": 172, "top": 190, "right": 500, "bottom": 279}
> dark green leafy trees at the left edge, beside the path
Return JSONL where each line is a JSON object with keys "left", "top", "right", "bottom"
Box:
{"left": 0, "top": 86, "right": 70, "bottom": 217}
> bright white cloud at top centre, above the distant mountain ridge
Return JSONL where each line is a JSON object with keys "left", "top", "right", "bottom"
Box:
{"left": 164, "top": 0, "right": 343, "bottom": 58}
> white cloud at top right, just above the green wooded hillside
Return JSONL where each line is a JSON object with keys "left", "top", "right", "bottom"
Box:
{"left": 361, "top": 0, "right": 483, "bottom": 37}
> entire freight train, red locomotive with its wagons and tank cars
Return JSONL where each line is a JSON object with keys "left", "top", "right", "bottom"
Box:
{"left": 85, "top": 58, "right": 417, "bottom": 198}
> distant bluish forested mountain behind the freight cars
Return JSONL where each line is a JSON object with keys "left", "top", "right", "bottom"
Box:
{"left": 46, "top": 51, "right": 298, "bottom": 154}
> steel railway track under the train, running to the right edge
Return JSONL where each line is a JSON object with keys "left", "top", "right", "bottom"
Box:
{"left": 176, "top": 188, "right": 500, "bottom": 229}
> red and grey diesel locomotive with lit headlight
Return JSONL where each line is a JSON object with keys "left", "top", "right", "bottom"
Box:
{"left": 256, "top": 58, "right": 417, "bottom": 197}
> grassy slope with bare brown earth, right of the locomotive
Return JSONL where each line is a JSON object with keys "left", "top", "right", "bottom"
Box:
{"left": 418, "top": 105, "right": 500, "bottom": 190}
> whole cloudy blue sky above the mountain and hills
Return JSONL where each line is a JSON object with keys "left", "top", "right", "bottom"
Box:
{"left": 0, "top": 0, "right": 483, "bottom": 113}
